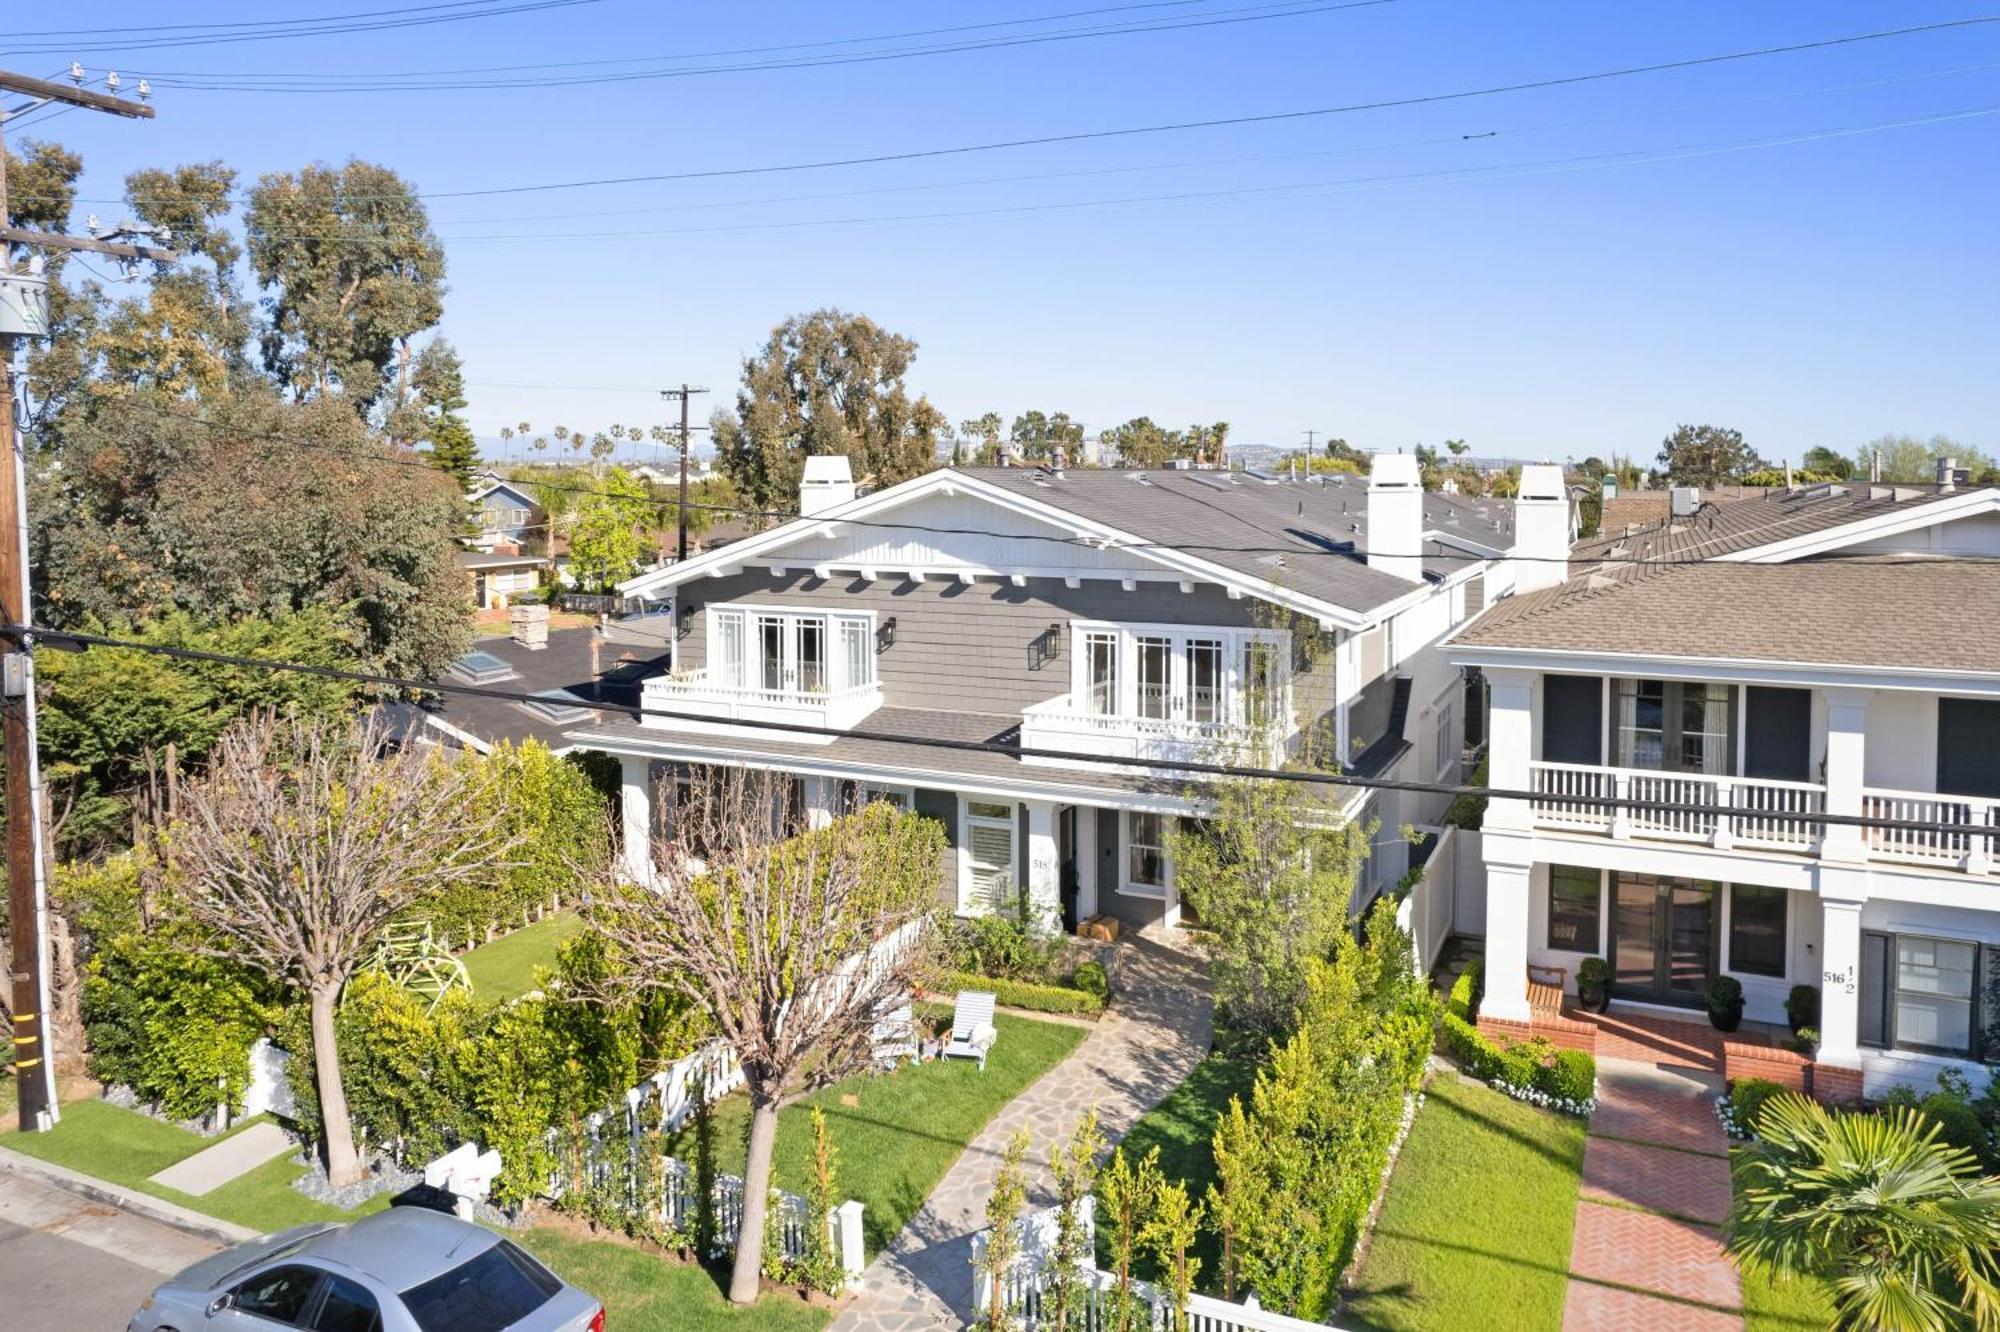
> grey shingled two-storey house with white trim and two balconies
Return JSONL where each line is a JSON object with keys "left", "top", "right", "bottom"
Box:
{"left": 572, "top": 454, "right": 1544, "bottom": 926}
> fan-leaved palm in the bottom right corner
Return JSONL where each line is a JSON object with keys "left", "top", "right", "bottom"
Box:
{"left": 1726, "top": 1092, "right": 2000, "bottom": 1332}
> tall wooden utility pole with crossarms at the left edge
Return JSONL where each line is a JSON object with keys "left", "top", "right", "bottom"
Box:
{"left": 0, "top": 70, "right": 178, "bottom": 1132}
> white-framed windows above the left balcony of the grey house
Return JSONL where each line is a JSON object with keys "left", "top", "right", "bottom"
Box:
{"left": 708, "top": 606, "right": 876, "bottom": 696}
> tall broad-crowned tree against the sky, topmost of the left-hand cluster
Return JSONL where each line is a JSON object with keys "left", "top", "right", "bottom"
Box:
{"left": 244, "top": 160, "right": 444, "bottom": 412}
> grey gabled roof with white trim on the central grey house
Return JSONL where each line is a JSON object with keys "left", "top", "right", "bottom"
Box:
{"left": 620, "top": 468, "right": 1514, "bottom": 628}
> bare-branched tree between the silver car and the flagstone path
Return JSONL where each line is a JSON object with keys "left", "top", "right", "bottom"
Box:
{"left": 594, "top": 768, "right": 944, "bottom": 1304}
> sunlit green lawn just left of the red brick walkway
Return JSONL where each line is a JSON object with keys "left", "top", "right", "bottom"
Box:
{"left": 1342, "top": 1072, "right": 1584, "bottom": 1332}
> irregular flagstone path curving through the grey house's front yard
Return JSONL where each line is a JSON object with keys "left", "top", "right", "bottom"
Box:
{"left": 832, "top": 938, "right": 1212, "bottom": 1332}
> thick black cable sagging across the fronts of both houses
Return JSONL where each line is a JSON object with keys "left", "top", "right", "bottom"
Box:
{"left": 19, "top": 624, "right": 2000, "bottom": 838}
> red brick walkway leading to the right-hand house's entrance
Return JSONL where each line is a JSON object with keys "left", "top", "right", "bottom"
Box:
{"left": 1562, "top": 1056, "right": 1744, "bottom": 1332}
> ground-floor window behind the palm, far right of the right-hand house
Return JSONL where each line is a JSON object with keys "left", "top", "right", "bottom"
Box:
{"left": 1860, "top": 932, "right": 1994, "bottom": 1058}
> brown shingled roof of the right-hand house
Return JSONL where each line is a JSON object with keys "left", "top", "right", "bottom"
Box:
{"left": 1452, "top": 484, "right": 2000, "bottom": 676}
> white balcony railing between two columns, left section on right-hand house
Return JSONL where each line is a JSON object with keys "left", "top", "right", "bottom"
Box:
{"left": 1528, "top": 762, "right": 1826, "bottom": 852}
